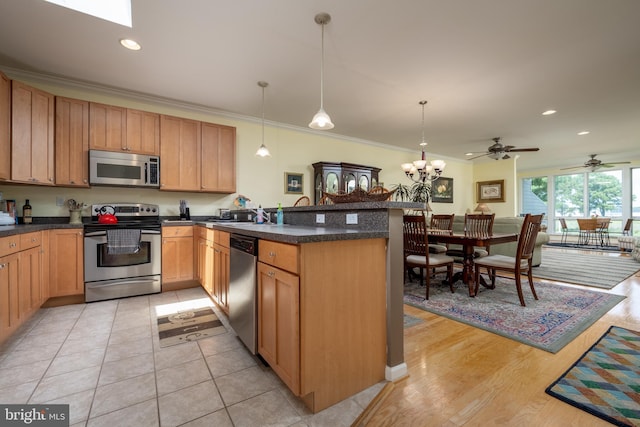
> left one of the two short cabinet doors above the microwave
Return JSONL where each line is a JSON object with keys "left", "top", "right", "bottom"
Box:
{"left": 89, "top": 102, "right": 127, "bottom": 151}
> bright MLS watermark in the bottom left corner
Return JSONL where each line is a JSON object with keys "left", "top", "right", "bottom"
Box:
{"left": 0, "top": 404, "right": 69, "bottom": 427}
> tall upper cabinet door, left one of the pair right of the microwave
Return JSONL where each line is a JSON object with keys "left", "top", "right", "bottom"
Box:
{"left": 160, "top": 115, "right": 200, "bottom": 191}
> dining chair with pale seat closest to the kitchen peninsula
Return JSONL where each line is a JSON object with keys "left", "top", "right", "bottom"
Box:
{"left": 402, "top": 215, "right": 454, "bottom": 299}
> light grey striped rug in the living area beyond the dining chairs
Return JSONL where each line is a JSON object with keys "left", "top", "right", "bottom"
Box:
{"left": 533, "top": 248, "right": 640, "bottom": 289}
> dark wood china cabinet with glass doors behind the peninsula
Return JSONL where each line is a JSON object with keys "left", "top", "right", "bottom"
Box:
{"left": 313, "top": 162, "right": 380, "bottom": 204}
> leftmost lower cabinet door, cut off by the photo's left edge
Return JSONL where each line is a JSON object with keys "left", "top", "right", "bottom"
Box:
{"left": 0, "top": 253, "right": 20, "bottom": 342}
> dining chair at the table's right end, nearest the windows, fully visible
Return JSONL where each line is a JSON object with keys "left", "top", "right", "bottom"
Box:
{"left": 474, "top": 214, "right": 543, "bottom": 307}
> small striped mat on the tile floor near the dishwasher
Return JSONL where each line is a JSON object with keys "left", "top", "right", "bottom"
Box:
{"left": 158, "top": 307, "right": 226, "bottom": 347}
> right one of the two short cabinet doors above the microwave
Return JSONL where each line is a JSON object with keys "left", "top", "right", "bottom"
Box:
{"left": 126, "top": 109, "right": 160, "bottom": 156}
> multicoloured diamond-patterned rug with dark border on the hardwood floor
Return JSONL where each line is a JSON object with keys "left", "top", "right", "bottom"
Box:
{"left": 545, "top": 326, "right": 640, "bottom": 426}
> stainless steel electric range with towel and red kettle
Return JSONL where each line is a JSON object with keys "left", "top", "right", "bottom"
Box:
{"left": 84, "top": 203, "right": 162, "bottom": 302}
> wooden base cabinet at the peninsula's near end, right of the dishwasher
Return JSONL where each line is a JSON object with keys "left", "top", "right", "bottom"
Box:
{"left": 258, "top": 239, "right": 387, "bottom": 412}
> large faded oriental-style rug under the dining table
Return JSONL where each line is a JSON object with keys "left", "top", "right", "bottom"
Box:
{"left": 404, "top": 279, "right": 626, "bottom": 353}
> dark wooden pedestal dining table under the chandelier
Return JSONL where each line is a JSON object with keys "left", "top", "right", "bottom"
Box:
{"left": 427, "top": 230, "right": 518, "bottom": 297}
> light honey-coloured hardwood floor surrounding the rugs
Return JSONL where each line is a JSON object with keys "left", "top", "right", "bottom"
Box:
{"left": 367, "top": 248, "right": 640, "bottom": 427}
